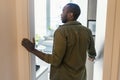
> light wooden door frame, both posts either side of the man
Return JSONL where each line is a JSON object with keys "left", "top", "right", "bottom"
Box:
{"left": 16, "top": 0, "right": 120, "bottom": 80}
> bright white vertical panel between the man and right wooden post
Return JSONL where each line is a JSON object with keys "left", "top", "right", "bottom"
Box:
{"left": 94, "top": 0, "right": 107, "bottom": 80}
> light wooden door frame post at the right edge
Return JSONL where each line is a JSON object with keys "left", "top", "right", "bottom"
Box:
{"left": 103, "top": 0, "right": 120, "bottom": 80}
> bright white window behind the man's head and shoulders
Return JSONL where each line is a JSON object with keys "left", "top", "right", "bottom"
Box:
{"left": 34, "top": 0, "right": 87, "bottom": 41}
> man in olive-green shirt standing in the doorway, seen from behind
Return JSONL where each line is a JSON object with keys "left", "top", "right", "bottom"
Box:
{"left": 22, "top": 3, "right": 96, "bottom": 80}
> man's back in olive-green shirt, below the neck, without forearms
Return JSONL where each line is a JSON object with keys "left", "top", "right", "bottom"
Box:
{"left": 51, "top": 21, "right": 95, "bottom": 80}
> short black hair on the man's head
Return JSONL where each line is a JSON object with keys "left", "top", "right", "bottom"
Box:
{"left": 67, "top": 3, "right": 81, "bottom": 20}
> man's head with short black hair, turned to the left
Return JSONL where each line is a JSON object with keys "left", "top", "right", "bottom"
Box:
{"left": 61, "top": 3, "right": 81, "bottom": 23}
